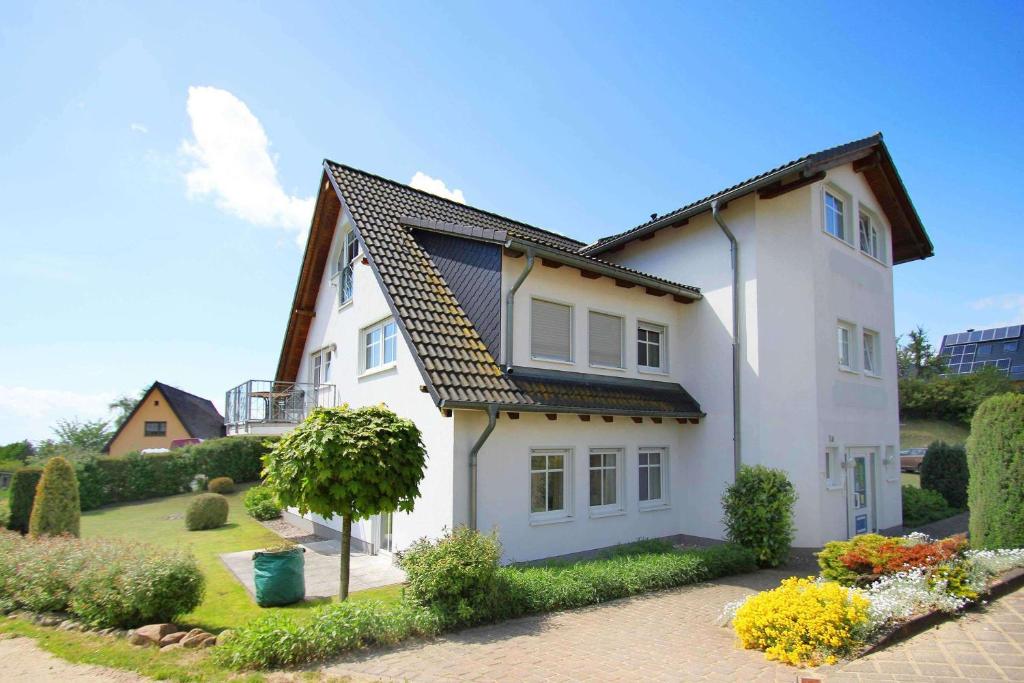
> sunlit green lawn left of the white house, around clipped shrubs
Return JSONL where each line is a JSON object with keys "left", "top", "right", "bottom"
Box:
{"left": 82, "top": 492, "right": 401, "bottom": 633}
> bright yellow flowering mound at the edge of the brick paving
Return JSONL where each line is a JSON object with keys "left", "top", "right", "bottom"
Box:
{"left": 733, "top": 577, "right": 868, "bottom": 666}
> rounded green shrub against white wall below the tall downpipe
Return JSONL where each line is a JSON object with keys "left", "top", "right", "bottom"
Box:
{"left": 722, "top": 465, "right": 797, "bottom": 566}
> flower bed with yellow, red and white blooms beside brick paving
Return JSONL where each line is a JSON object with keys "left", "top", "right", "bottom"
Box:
{"left": 725, "top": 533, "right": 1024, "bottom": 666}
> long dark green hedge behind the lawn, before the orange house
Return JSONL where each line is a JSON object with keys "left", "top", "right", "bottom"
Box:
{"left": 77, "top": 436, "right": 276, "bottom": 510}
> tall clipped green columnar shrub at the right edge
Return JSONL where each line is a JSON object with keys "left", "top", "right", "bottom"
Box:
{"left": 967, "top": 394, "right": 1024, "bottom": 548}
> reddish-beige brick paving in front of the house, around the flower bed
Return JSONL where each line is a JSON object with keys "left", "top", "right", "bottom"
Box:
{"left": 321, "top": 570, "right": 1024, "bottom": 683}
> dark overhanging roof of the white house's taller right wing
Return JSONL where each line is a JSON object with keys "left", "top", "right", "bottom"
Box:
{"left": 581, "top": 133, "right": 934, "bottom": 263}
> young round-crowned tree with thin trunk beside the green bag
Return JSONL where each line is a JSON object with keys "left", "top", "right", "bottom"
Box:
{"left": 263, "top": 405, "right": 427, "bottom": 600}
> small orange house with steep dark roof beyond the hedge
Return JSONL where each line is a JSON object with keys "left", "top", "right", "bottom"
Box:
{"left": 103, "top": 382, "right": 224, "bottom": 456}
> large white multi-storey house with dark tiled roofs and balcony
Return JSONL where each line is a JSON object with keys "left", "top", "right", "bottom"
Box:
{"left": 228, "top": 134, "right": 932, "bottom": 560}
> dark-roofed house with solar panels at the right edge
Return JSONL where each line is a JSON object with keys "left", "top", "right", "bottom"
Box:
{"left": 939, "top": 325, "right": 1024, "bottom": 382}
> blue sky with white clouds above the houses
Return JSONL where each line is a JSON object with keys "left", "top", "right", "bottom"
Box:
{"left": 0, "top": 0, "right": 1024, "bottom": 443}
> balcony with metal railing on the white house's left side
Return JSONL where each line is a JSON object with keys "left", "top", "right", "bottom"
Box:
{"left": 224, "top": 380, "right": 337, "bottom": 436}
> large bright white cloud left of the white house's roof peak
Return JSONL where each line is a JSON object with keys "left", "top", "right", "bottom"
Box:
{"left": 181, "top": 86, "right": 313, "bottom": 244}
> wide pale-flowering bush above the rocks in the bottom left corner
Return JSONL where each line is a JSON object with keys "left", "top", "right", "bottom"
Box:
{"left": 0, "top": 531, "right": 204, "bottom": 628}
